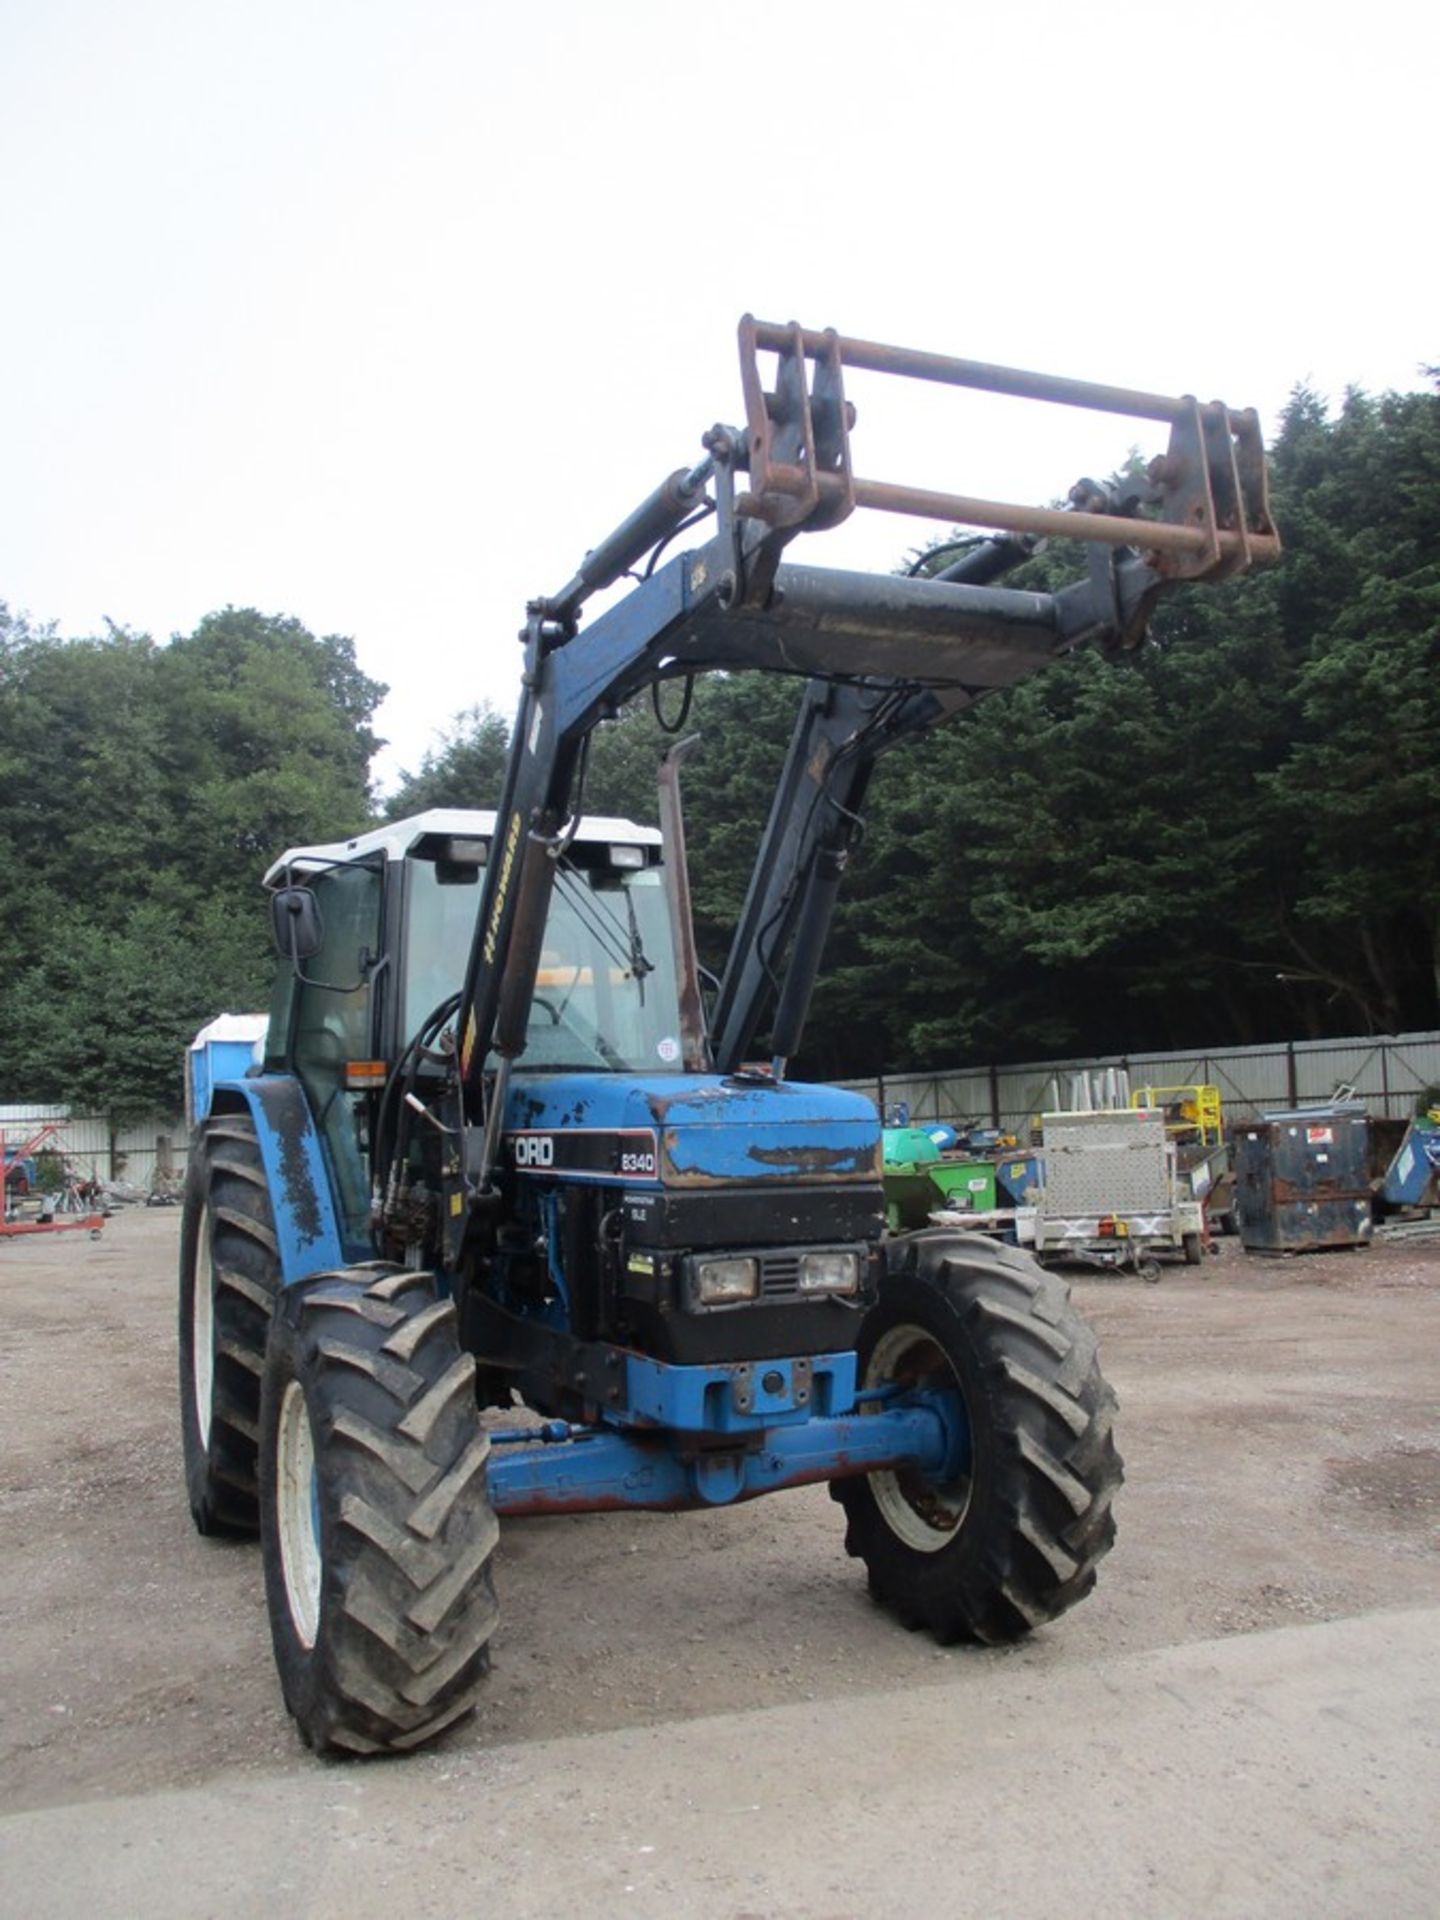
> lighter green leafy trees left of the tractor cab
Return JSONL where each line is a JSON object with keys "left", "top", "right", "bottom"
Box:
{"left": 0, "top": 609, "right": 384, "bottom": 1117}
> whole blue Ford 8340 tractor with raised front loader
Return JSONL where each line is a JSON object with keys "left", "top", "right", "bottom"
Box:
{"left": 179, "top": 319, "right": 1277, "bottom": 1753}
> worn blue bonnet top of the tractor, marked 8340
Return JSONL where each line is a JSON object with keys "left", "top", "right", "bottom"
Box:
{"left": 505, "top": 1071, "right": 879, "bottom": 1187}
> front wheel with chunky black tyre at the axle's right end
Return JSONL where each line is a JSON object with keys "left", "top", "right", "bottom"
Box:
{"left": 831, "top": 1233, "right": 1121, "bottom": 1645}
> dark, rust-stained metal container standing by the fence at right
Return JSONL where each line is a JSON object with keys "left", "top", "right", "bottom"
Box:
{"left": 1235, "top": 1102, "right": 1371, "bottom": 1254}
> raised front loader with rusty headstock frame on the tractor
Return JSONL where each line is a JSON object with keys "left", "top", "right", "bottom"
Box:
{"left": 451, "top": 317, "right": 1279, "bottom": 1194}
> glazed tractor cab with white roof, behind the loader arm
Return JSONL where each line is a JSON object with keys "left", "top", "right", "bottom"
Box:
{"left": 265, "top": 808, "right": 682, "bottom": 1254}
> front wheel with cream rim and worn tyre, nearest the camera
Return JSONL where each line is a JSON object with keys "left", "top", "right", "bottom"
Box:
{"left": 261, "top": 1263, "right": 499, "bottom": 1753}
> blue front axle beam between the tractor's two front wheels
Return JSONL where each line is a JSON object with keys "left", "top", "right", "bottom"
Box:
{"left": 490, "top": 1396, "right": 968, "bottom": 1515}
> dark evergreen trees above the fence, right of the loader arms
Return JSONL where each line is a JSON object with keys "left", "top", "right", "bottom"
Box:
{"left": 806, "top": 366, "right": 1440, "bottom": 1069}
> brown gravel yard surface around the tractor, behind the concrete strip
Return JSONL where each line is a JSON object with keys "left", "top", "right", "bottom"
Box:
{"left": 0, "top": 1210, "right": 1440, "bottom": 1812}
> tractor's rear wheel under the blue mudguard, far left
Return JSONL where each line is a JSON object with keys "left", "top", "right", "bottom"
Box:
{"left": 179, "top": 1114, "right": 280, "bottom": 1534}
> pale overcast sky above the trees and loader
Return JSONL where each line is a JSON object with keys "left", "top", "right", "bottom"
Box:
{"left": 0, "top": 0, "right": 1440, "bottom": 781}
